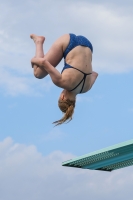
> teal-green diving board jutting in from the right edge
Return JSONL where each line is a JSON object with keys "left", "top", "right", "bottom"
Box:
{"left": 62, "top": 140, "right": 133, "bottom": 171}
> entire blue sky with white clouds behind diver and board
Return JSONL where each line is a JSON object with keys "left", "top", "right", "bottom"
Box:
{"left": 0, "top": 0, "right": 133, "bottom": 200}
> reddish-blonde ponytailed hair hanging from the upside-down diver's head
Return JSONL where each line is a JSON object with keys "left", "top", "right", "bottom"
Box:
{"left": 53, "top": 99, "right": 76, "bottom": 126}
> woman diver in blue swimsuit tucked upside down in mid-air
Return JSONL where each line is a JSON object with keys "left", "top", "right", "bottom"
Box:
{"left": 30, "top": 34, "right": 98, "bottom": 125}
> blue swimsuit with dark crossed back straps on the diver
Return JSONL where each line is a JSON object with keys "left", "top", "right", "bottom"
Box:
{"left": 61, "top": 33, "right": 93, "bottom": 93}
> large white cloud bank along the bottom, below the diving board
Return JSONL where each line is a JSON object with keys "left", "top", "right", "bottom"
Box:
{"left": 0, "top": 138, "right": 133, "bottom": 200}
